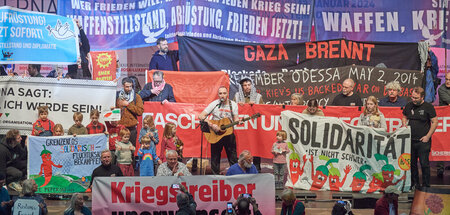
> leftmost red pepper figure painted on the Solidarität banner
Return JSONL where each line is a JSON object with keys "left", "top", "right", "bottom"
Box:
{"left": 309, "top": 155, "right": 339, "bottom": 190}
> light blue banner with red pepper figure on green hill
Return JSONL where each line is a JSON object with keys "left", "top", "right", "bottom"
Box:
{"left": 28, "top": 134, "right": 108, "bottom": 193}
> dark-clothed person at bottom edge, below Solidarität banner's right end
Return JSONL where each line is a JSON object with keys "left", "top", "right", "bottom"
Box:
{"left": 374, "top": 185, "right": 401, "bottom": 215}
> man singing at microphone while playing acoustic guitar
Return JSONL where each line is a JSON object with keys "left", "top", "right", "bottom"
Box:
{"left": 198, "top": 86, "right": 239, "bottom": 175}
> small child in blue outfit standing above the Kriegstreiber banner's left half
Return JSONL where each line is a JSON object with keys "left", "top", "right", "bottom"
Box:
{"left": 138, "top": 136, "right": 162, "bottom": 176}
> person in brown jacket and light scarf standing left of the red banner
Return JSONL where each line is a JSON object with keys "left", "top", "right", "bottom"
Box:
{"left": 116, "top": 77, "right": 144, "bottom": 147}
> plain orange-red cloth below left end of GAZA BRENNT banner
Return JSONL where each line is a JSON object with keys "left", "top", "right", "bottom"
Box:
{"left": 145, "top": 70, "right": 230, "bottom": 104}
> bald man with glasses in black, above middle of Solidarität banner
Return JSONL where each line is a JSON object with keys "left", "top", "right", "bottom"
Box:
{"left": 331, "top": 78, "right": 363, "bottom": 106}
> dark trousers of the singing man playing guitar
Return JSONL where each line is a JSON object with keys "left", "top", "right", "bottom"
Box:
{"left": 211, "top": 134, "right": 237, "bottom": 175}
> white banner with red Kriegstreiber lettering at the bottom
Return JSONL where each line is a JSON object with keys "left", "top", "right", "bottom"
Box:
{"left": 92, "top": 173, "right": 275, "bottom": 215}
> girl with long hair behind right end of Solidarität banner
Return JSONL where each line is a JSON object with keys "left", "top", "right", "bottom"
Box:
{"left": 358, "top": 96, "right": 387, "bottom": 130}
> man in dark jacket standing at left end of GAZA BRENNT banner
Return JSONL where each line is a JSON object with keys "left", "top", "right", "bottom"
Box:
{"left": 149, "top": 37, "right": 180, "bottom": 71}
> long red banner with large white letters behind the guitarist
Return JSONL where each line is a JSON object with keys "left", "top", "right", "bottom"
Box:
{"left": 138, "top": 102, "right": 450, "bottom": 161}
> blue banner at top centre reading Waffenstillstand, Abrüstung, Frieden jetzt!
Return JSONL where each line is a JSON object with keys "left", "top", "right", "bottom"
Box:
{"left": 58, "top": 0, "right": 312, "bottom": 50}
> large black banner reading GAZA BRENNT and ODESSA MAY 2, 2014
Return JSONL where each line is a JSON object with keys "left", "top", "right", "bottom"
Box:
{"left": 178, "top": 37, "right": 421, "bottom": 105}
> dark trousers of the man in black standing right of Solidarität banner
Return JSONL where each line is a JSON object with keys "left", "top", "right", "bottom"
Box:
{"left": 411, "top": 140, "right": 431, "bottom": 187}
